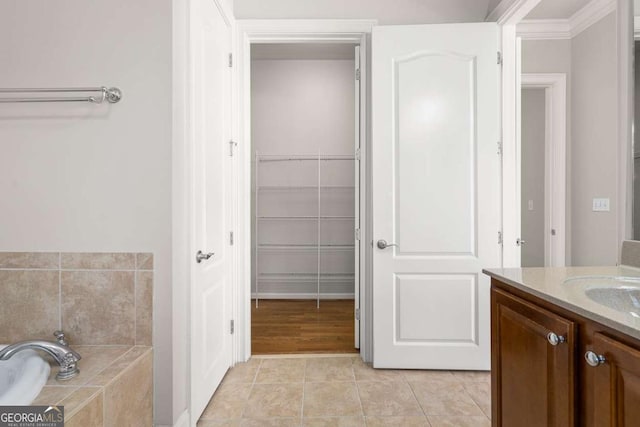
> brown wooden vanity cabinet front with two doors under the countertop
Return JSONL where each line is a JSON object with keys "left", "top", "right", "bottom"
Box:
{"left": 491, "top": 279, "right": 640, "bottom": 427}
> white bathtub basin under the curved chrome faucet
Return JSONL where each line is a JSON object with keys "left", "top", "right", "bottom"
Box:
{"left": 0, "top": 345, "right": 51, "bottom": 406}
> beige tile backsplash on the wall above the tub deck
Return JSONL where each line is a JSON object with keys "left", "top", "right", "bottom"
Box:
{"left": 0, "top": 252, "right": 153, "bottom": 346}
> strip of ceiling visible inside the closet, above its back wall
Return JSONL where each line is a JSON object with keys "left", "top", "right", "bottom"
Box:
{"left": 251, "top": 43, "right": 355, "bottom": 60}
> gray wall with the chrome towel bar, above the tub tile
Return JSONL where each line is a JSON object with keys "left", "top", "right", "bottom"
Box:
{"left": 0, "top": 0, "right": 173, "bottom": 424}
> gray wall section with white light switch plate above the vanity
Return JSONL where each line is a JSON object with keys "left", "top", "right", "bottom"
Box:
{"left": 570, "top": 13, "right": 619, "bottom": 265}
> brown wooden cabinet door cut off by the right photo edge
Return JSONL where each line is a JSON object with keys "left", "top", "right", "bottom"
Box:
{"left": 584, "top": 333, "right": 640, "bottom": 427}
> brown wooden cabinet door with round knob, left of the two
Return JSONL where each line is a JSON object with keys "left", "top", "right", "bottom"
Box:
{"left": 491, "top": 289, "right": 576, "bottom": 427}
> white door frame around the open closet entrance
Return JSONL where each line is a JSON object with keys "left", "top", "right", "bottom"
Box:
{"left": 233, "top": 19, "right": 377, "bottom": 363}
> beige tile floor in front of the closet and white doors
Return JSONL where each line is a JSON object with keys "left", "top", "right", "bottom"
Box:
{"left": 198, "top": 356, "right": 491, "bottom": 427}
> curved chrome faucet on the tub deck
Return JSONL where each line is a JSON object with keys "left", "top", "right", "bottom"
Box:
{"left": 0, "top": 331, "right": 82, "bottom": 380}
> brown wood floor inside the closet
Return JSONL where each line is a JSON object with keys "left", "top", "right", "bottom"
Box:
{"left": 251, "top": 300, "right": 357, "bottom": 355}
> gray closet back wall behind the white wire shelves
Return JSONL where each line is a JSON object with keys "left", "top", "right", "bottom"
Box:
{"left": 251, "top": 60, "right": 355, "bottom": 298}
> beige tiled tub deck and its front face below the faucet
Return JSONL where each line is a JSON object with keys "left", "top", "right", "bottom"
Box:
{"left": 33, "top": 346, "right": 153, "bottom": 427}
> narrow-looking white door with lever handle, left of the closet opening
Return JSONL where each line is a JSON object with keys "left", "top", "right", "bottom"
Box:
{"left": 190, "top": 0, "right": 232, "bottom": 425}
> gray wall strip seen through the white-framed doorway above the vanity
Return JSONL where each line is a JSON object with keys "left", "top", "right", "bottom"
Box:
{"left": 522, "top": 89, "right": 545, "bottom": 267}
